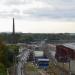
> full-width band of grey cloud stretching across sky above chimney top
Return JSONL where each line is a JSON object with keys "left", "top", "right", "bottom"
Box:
{"left": 0, "top": 9, "right": 75, "bottom": 20}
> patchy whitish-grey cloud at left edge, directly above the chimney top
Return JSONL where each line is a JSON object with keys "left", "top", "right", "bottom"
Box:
{"left": 0, "top": 9, "right": 29, "bottom": 19}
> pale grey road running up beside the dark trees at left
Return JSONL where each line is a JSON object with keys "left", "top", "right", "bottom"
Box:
{"left": 17, "top": 49, "right": 29, "bottom": 75}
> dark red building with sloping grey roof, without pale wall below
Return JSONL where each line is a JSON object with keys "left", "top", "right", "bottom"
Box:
{"left": 55, "top": 43, "right": 75, "bottom": 62}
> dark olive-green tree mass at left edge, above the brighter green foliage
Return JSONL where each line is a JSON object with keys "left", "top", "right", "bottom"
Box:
{"left": 0, "top": 43, "right": 19, "bottom": 68}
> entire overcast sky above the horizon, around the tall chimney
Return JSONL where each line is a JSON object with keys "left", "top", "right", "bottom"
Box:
{"left": 0, "top": 0, "right": 75, "bottom": 33}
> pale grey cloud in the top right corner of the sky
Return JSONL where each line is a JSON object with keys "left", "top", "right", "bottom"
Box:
{"left": 39, "top": 0, "right": 75, "bottom": 9}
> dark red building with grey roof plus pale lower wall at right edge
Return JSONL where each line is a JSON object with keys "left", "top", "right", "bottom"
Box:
{"left": 55, "top": 43, "right": 75, "bottom": 75}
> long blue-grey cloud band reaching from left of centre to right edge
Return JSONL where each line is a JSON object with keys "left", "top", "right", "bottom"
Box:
{"left": 24, "top": 9, "right": 75, "bottom": 19}
